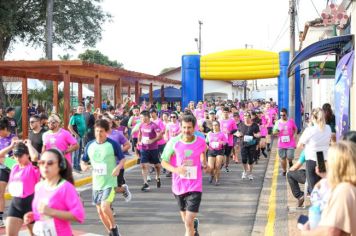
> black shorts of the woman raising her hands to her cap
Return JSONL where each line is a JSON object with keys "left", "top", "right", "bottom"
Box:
{"left": 7, "top": 194, "right": 34, "bottom": 219}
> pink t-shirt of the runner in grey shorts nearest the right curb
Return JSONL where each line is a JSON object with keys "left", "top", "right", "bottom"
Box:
{"left": 275, "top": 119, "right": 297, "bottom": 149}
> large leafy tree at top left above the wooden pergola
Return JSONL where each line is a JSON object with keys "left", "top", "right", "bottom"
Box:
{"left": 0, "top": 0, "right": 111, "bottom": 106}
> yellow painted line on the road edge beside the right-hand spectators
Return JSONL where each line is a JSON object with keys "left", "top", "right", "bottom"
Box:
{"left": 265, "top": 155, "right": 279, "bottom": 236}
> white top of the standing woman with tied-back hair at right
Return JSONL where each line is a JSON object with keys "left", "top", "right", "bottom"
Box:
{"left": 299, "top": 125, "right": 331, "bottom": 161}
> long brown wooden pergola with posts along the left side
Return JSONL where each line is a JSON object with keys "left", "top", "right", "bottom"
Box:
{"left": 0, "top": 60, "right": 181, "bottom": 138}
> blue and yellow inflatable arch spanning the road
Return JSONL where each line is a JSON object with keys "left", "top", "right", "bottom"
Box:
{"left": 182, "top": 49, "right": 301, "bottom": 129}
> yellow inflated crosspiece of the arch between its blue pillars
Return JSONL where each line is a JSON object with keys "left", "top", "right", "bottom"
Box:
{"left": 200, "top": 49, "right": 279, "bottom": 80}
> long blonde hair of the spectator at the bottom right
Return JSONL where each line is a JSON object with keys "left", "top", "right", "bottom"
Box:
{"left": 327, "top": 141, "right": 356, "bottom": 188}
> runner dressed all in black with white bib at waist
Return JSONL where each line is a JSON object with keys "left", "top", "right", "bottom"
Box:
{"left": 236, "top": 112, "right": 260, "bottom": 180}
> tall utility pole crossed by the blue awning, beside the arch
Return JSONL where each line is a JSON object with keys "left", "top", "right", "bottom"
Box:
{"left": 288, "top": 0, "right": 296, "bottom": 120}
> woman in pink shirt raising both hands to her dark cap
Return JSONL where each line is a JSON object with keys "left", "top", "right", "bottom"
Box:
{"left": 0, "top": 139, "right": 40, "bottom": 235}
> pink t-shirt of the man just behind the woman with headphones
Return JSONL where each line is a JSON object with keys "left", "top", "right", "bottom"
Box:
{"left": 42, "top": 128, "right": 77, "bottom": 164}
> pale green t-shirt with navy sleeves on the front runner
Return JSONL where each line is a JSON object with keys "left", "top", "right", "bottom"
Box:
{"left": 82, "top": 138, "right": 124, "bottom": 190}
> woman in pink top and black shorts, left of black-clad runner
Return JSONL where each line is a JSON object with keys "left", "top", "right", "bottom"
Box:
{"left": 206, "top": 121, "right": 228, "bottom": 186}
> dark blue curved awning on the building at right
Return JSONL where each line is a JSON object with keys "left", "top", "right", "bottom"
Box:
{"left": 288, "top": 35, "right": 354, "bottom": 76}
